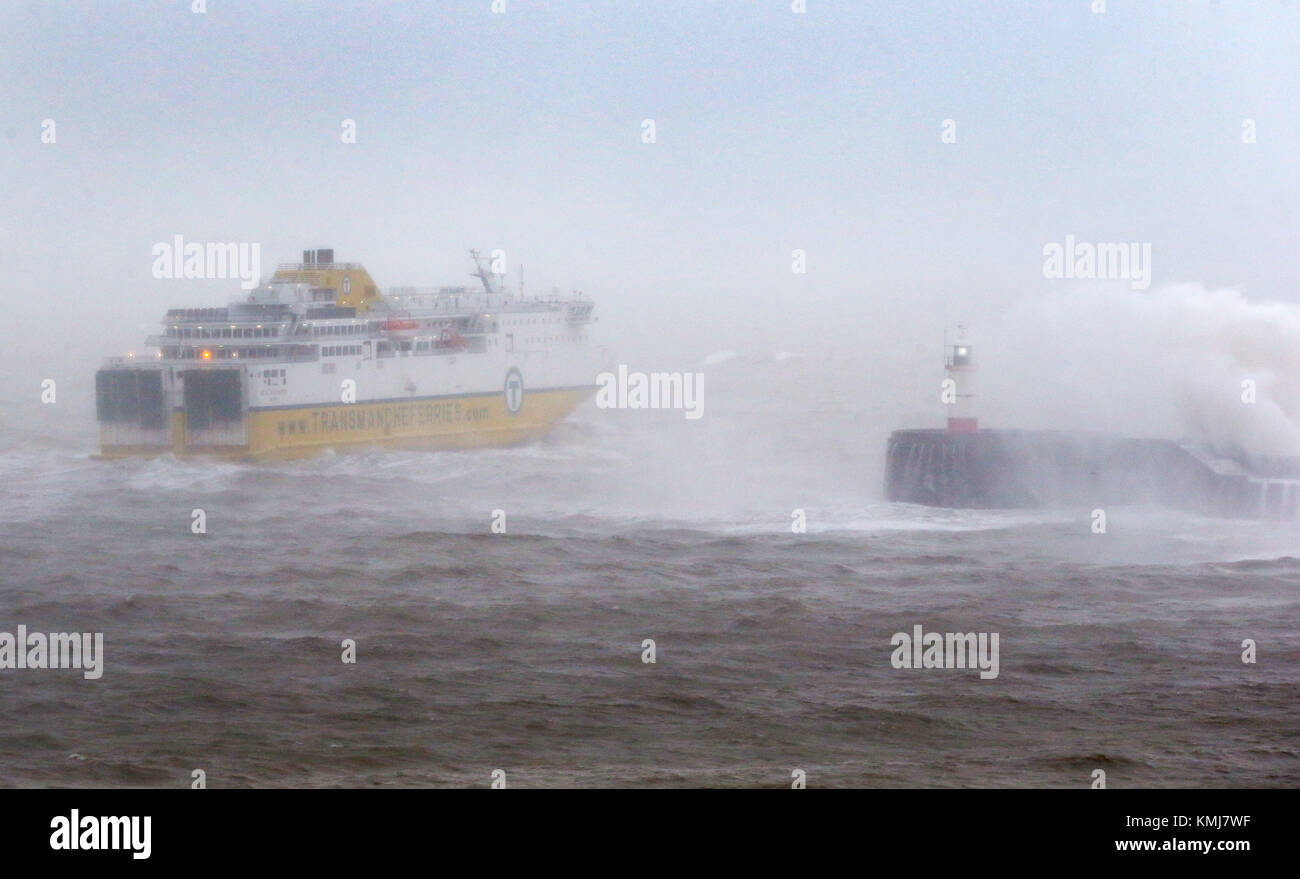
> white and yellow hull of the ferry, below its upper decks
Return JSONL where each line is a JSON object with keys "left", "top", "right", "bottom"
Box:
{"left": 100, "top": 352, "right": 595, "bottom": 459}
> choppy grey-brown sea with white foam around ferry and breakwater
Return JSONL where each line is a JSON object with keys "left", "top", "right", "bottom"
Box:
{"left": 0, "top": 358, "right": 1300, "bottom": 788}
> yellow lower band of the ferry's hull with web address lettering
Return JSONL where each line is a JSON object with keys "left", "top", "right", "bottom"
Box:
{"left": 101, "top": 387, "right": 595, "bottom": 459}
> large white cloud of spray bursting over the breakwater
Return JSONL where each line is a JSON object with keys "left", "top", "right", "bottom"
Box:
{"left": 979, "top": 282, "right": 1300, "bottom": 454}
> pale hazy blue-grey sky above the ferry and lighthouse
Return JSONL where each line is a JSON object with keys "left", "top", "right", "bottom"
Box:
{"left": 0, "top": 0, "right": 1300, "bottom": 447}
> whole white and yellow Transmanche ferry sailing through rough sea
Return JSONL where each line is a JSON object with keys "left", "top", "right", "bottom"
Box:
{"left": 95, "top": 248, "right": 606, "bottom": 459}
